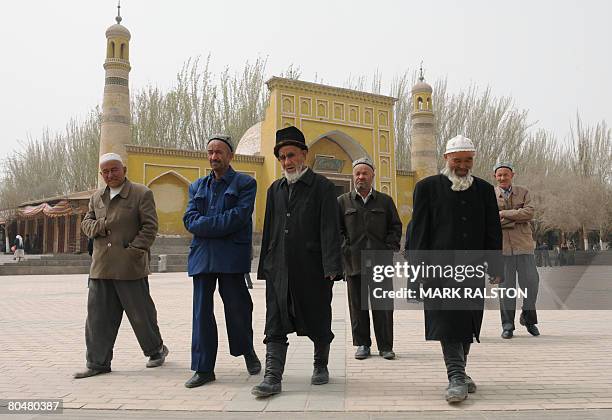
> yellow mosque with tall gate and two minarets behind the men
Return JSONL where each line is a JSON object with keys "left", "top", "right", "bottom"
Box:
{"left": 100, "top": 10, "right": 435, "bottom": 235}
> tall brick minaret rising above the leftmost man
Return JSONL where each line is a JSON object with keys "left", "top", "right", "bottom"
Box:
{"left": 98, "top": 4, "right": 132, "bottom": 187}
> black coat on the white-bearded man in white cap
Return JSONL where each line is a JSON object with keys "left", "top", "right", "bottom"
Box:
{"left": 406, "top": 175, "right": 503, "bottom": 342}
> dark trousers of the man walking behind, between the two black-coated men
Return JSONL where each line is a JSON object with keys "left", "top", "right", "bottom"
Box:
{"left": 347, "top": 275, "right": 393, "bottom": 351}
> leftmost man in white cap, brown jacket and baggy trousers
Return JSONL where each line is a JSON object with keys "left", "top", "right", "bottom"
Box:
{"left": 74, "top": 153, "right": 168, "bottom": 379}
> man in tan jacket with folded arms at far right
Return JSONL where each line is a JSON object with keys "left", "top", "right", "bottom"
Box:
{"left": 494, "top": 162, "right": 540, "bottom": 339}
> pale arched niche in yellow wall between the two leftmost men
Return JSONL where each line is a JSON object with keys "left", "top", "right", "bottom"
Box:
{"left": 148, "top": 171, "right": 190, "bottom": 236}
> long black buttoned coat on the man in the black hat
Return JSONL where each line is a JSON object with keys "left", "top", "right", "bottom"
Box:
{"left": 257, "top": 169, "right": 342, "bottom": 342}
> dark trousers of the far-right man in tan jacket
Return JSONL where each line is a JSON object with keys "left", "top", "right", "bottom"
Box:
{"left": 500, "top": 254, "right": 540, "bottom": 330}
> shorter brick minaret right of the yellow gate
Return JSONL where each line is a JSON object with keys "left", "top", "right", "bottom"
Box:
{"left": 410, "top": 66, "right": 438, "bottom": 180}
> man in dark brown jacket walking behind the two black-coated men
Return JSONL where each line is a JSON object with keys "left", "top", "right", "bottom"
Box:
{"left": 338, "top": 158, "right": 402, "bottom": 360}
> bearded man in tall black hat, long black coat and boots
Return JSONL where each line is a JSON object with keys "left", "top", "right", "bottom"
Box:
{"left": 251, "top": 127, "right": 342, "bottom": 397}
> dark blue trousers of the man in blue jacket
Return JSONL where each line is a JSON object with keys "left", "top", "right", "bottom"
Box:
{"left": 191, "top": 273, "right": 253, "bottom": 372}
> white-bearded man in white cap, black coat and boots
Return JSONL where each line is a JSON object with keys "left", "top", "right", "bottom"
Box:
{"left": 406, "top": 135, "right": 503, "bottom": 403}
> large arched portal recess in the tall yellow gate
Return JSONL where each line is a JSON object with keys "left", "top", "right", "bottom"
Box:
{"left": 307, "top": 130, "right": 371, "bottom": 196}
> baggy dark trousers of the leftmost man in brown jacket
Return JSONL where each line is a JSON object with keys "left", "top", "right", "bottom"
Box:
{"left": 85, "top": 277, "right": 163, "bottom": 370}
